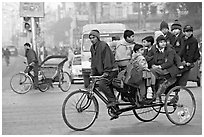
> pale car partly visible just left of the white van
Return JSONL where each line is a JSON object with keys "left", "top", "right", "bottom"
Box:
{"left": 71, "top": 54, "right": 83, "bottom": 83}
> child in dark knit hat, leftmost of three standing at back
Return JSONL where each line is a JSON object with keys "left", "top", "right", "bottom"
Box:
{"left": 160, "top": 21, "right": 175, "bottom": 45}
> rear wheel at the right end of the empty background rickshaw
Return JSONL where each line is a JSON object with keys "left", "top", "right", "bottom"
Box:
{"left": 59, "top": 72, "right": 71, "bottom": 92}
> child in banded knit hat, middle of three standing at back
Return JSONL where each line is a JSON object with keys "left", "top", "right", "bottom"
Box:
{"left": 171, "top": 20, "right": 184, "bottom": 56}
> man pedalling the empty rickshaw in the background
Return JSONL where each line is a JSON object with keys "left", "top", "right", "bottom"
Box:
{"left": 24, "top": 43, "right": 38, "bottom": 89}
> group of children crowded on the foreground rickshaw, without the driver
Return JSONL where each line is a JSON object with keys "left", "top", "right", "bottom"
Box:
{"left": 112, "top": 20, "right": 200, "bottom": 103}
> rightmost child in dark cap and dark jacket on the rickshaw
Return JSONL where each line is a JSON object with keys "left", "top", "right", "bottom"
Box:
{"left": 179, "top": 25, "right": 200, "bottom": 86}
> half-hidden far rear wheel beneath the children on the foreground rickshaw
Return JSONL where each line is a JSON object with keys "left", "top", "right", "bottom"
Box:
{"left": 133, "top": 98, "right": 162, "bottom": 122}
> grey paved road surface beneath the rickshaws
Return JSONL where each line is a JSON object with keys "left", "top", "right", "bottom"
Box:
{"left": 2, "top": 57, "right": 202, "bottom": 135}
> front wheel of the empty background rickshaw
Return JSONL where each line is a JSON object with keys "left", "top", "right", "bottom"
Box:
{"left": 10, "top": 73, "right": 33, "bottom": 94}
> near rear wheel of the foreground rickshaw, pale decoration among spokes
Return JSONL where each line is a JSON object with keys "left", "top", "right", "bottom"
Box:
{"left": 164, "top": 86, "right": 196, "bottom": 125}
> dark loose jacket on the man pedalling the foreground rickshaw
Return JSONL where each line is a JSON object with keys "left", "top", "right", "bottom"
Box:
{"left": 90, "top": 41, "right": 117, "bottom": 75}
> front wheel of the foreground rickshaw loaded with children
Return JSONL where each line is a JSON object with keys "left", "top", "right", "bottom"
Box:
{"left": 62, "top": 90, "right": 99, "bottom": 131}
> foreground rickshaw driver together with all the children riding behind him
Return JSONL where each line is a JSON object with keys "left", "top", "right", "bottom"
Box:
{"left": 89, "top": 20, "right": 200, "bottom": 117}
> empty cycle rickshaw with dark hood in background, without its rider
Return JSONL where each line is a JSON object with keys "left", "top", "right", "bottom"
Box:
{"left": 10, "top": 55, "right": 71, "bottom": 94}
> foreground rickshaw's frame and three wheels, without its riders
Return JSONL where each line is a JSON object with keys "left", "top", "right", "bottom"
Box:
{"left": 62, "top": 76, "right": 196, "bottom": 131}
